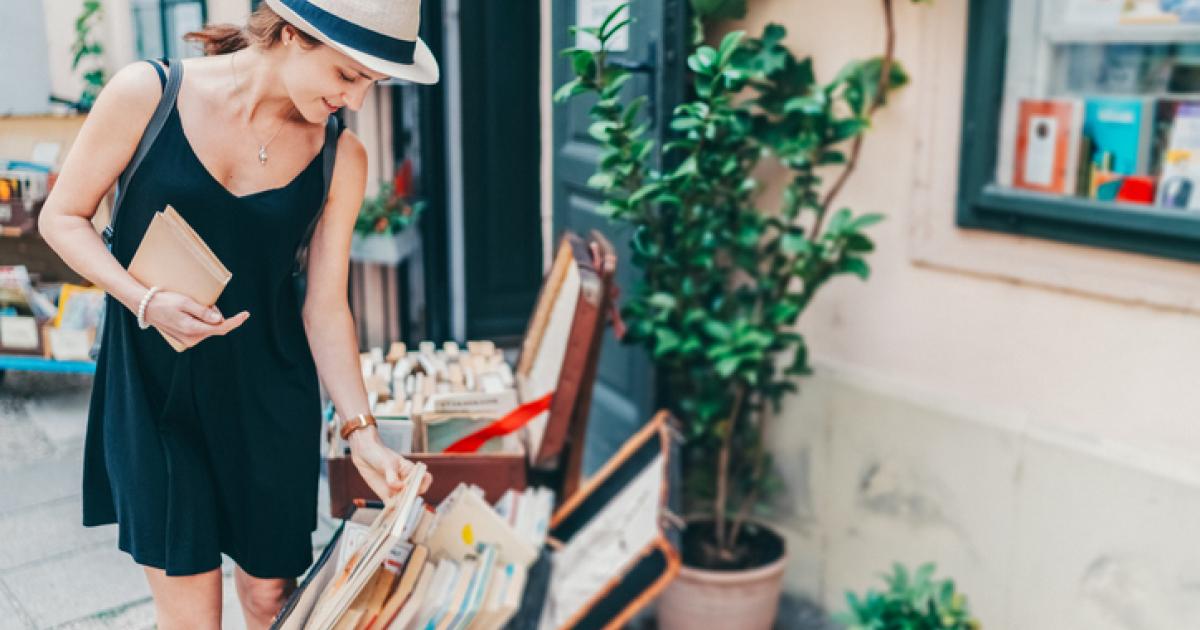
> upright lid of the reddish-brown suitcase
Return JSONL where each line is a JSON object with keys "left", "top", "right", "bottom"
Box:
{"left": 515, "top": 232, "right": 617, "bottom": 470}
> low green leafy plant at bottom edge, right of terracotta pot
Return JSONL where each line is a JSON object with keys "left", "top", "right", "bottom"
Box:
{"left": 834, "top": 563, "right": 980, "bottom": 630}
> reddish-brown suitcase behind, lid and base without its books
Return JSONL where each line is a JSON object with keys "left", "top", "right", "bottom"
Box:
{"left": 326, "top": 232, "right": 617, "bottom": 518}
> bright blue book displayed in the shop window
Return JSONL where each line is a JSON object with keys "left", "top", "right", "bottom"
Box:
{"left": 1084, "top": 97, "right": 1153, "bottom": 175}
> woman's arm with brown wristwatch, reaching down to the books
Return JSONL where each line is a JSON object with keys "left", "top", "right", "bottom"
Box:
{"left": 302, "top": 130, "right": 432, "bottom": 497}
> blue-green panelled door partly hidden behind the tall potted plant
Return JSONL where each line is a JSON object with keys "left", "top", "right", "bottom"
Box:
{"left": 551, "top": 0, "right": 688, "bottom": 474}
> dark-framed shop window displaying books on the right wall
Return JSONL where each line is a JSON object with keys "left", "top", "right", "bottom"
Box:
{"left": 958, "top": 0, "right": 1200, "bottom": 260}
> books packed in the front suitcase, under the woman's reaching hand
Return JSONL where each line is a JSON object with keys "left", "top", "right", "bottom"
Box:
{"left": 292, "top": 463, "right": 553, "bottom": 630}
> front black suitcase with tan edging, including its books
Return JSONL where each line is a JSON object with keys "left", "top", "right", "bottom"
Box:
{"left": 272, "top": 412, "right": 680, "bottom": 630}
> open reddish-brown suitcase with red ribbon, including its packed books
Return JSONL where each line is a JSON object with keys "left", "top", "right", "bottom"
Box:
{"left": 326, "top": 233, "right": 617, "bottom": 517}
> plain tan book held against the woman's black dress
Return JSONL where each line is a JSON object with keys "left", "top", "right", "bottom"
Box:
{"left": 128, "top": 205, "right": 233, "bottom": 352}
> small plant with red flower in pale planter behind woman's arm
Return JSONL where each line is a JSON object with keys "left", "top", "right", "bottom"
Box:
{"left": 350, "top": 160, "right": 425, "bottom": 265}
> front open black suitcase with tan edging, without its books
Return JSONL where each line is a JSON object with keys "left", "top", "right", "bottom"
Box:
{"left": 271, "top": 412, "right": 680, "bottom": 630}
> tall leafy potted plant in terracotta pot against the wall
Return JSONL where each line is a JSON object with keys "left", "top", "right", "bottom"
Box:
{"left": 554, "top": 0, "right": 907, "bottom": 629}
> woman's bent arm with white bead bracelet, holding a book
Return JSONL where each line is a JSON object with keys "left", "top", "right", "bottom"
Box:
{"left": 37, "top": 62, "right": 250, "bottom": 347}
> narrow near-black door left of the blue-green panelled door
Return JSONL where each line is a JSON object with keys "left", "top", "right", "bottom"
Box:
{"left": 457, "top": 0, "right": 541, "bottom": 341}
